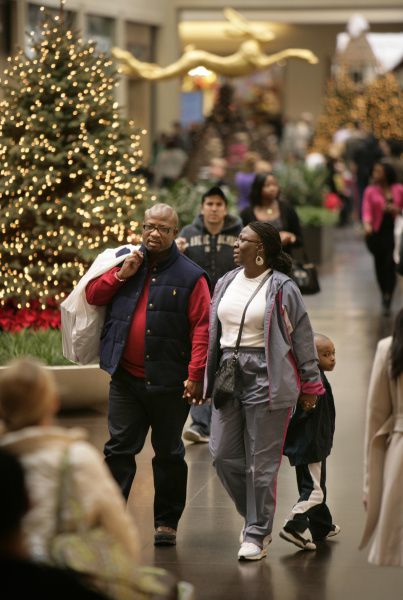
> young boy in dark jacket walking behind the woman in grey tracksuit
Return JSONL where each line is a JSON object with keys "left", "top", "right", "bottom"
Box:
{"left": 280, "top": 334, "right": 340, "bottom": 550}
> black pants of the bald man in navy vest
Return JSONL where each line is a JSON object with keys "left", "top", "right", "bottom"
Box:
{"left": 104, "top": 367, "right": 189, "bottom": 529}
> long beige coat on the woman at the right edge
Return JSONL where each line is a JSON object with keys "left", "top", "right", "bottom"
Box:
{"left": 360, "top": 337, "right": 403, "bottom": 567}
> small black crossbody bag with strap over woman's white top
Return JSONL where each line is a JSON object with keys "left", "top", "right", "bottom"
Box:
{"left": 212, "top": 272, "right": 271, "bottom": 408}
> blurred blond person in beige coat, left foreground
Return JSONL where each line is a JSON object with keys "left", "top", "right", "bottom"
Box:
{"left": 0, "top": 358, "right": 140, "bottom": 580}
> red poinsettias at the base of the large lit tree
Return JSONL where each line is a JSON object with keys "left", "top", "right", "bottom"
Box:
{"left": 0, "top": 301, "right": 61, "bottom": 333}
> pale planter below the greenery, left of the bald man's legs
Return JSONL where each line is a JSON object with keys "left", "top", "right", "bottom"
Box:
{"left": 46, "top": 365, "right": 110, "bottom": 409}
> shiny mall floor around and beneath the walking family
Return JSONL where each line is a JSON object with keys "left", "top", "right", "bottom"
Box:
{"left": 60, "top": 228, "right": 403, "bottom": 600}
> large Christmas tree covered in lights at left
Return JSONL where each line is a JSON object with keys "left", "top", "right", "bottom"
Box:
{"left": 0, "top": 2, "right": 146, "bottom": 324}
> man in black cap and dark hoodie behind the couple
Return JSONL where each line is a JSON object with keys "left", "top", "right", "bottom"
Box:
{"left": 176, "top": 187, "right": 242, "bottom": 442}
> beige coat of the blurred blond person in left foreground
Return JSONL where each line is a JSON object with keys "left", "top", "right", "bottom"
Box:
{"left": 0, "top": 427, "right": 140, "bottom": 565}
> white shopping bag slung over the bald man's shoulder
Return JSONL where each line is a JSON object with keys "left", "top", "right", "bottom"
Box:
{"left": 60, "top": 244, "right": 139, "bottom": 365}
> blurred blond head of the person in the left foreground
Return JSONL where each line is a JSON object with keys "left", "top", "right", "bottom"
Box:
{"left": 0, "top": 358, "right": 59, "bottom": 431}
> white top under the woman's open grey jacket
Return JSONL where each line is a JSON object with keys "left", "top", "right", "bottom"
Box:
{"left": 217, "top": 269, "right": 270, "bottom": 348}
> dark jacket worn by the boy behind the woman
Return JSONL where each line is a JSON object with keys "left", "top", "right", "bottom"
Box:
{"left": 283, "top": 371, "right": 336, "bottom": 466}
